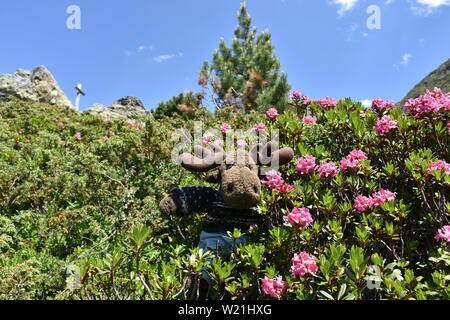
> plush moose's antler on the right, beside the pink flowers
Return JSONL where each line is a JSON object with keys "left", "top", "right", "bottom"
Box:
{"left": 250, "top": 141, "right": 294, "bottom": 166}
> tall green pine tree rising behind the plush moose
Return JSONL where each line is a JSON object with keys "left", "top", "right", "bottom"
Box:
{"left": 199, "top": 1, "right": 290, "bottom": 111}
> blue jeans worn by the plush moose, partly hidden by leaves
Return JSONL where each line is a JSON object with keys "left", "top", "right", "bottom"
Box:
{"left": 197, "top": 231, "right": 247, "bottom": 281}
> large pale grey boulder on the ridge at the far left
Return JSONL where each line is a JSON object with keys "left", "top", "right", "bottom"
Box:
{"left": 0, "top": 66, "right": 74, "bottom": 108}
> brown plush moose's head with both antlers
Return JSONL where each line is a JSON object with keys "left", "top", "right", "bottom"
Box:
{"left": 180, "top": 141, "right": 294, "bottom": 209}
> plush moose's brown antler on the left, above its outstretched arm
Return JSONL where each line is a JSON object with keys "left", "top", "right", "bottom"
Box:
{"left": 180, "top": 145, "right": 225, "bottom": 172}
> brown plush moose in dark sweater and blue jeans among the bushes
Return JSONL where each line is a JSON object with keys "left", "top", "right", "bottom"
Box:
{"left": 159, "top": 142, "right": 294, "bottom": 298}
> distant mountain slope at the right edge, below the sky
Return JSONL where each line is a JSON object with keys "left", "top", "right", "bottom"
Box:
{"left": 400, "top": 59, "right": 450, "bottom": 105}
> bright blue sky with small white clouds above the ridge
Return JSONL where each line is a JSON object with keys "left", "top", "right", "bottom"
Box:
{"left": 0, "top": 0, "right": 450, "bottom": 109}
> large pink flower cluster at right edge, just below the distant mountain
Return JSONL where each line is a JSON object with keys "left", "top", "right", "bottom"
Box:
{"left": 403, "top": 88, "right": 450, "bottom": 117}
